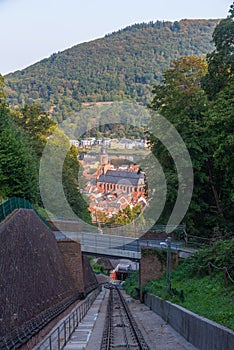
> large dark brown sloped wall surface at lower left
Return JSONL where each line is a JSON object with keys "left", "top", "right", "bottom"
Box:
{"left": 0, "top": 209, "right": 77, "bottom": 336}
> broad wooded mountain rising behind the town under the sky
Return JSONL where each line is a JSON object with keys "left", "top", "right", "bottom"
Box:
{"left": 5, "top": 19, "right": 219, "bottom": 122}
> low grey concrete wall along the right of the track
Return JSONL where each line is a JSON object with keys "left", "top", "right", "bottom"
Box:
{"left": 144, "top": 293, "right": 234, "bottom": 350}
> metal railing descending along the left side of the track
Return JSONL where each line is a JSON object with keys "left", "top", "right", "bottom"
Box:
{"left": 34, "top": 288, "right": 100, "bottom": 350}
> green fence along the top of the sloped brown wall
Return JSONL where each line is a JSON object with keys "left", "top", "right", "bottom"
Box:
{"left": 0, "top": 197, "right": 49, "bottom": 226}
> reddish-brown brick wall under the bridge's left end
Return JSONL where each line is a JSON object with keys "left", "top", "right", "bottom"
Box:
{"left": 58, "top": 239, "right": 84, "bottom": 292}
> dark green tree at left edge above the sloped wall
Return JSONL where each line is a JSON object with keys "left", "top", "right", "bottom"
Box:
{"left": 0, "top": 105, "right": 38, "bottom": 202}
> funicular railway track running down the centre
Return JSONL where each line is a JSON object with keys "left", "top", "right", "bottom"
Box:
{"left": 101, "top": 287, "right": 150, "bottom": 350}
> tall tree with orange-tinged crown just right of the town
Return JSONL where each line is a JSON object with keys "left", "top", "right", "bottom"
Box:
{"left": 150, "top": 57, "right": 230, "bottom": 235}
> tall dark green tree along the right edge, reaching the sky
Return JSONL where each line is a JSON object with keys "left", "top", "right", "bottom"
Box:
{"left": 199, "top": 3, "right": 234, "bottom": 234}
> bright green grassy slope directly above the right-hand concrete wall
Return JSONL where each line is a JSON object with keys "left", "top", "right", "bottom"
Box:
{"left": 144, "top": 267, "right": 234, "bottom": 330}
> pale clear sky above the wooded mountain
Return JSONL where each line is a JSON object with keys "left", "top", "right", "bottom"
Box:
{"left": 0, "top": 0, "right": 233, "bottom": 75}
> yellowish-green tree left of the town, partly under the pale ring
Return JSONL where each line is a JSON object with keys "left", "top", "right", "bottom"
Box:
{"left": 40, "top": 129, "right": 90, "bottom": 221}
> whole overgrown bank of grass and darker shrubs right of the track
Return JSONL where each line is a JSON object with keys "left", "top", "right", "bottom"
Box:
{"left": 125, "top": 239, "right": 234, "bottom": 330}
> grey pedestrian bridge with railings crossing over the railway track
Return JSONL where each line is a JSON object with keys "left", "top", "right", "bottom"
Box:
{"left": 53, "top": 231, "right": 193, "bottom": 261}
